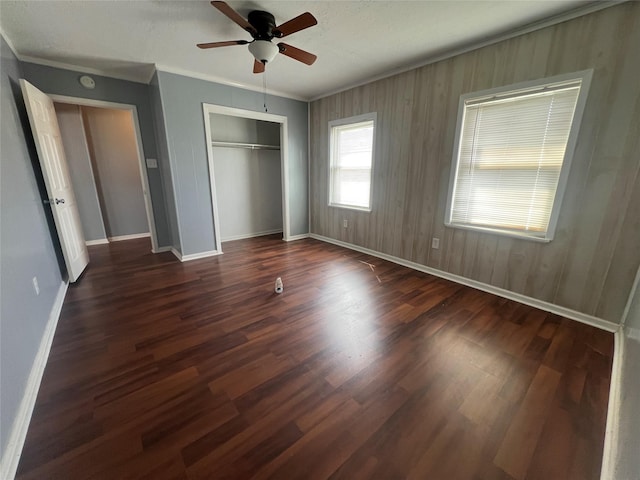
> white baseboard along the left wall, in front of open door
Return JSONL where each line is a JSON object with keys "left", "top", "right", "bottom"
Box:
{"left": 0, "top": 281, "right": 69, "bottom": 479}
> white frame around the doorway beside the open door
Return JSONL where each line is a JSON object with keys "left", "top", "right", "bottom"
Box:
{"left": 47, "top": 94, "right": 160, "bottom": 253}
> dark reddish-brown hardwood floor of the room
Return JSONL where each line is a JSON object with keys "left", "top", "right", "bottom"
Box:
{"left": 19, "top": 236, "right": 613, "bottom": 480}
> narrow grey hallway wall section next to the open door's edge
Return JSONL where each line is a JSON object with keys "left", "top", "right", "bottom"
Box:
{"left": 55, "top": 103, "right": 107, "bottom": 240}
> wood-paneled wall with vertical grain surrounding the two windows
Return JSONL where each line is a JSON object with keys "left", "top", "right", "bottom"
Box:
{"left": 310, "top": 2, "right": 640, "bottom": 322}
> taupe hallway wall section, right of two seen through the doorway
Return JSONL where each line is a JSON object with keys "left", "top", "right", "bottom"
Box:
{"left": 82, "top": 107, "right": 149, "bottom": 237}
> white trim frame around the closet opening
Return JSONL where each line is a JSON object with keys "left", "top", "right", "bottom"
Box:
{"left": 202, "top": 103, "right": 291, "bottom": 253}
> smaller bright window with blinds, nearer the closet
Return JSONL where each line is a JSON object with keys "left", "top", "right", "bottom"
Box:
{"left": 329, "top": 113, "right": 376, "bottom": 211}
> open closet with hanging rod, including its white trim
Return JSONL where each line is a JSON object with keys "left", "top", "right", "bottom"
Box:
{"left": 203, "top": 104, "right": 290, "bottom": 252}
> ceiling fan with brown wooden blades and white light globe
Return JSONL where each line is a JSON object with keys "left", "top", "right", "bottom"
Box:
{"left": 198, "top": 1, "right": 318, "bottom": 73}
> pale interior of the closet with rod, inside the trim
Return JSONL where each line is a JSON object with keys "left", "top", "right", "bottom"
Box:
{"left": 209, "top": 114, "right": 283, "bottom": 242}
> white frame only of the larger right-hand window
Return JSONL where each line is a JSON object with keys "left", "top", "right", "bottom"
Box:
{"left": 445, "top": 69, "right": 593, "bottom": 243}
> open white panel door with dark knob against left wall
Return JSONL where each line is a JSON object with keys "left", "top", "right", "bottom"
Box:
{"left": 20, "top": 79, "right": 89, "bottom": 282}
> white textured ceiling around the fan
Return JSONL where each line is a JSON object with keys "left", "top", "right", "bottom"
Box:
{"left": 0, "top": 0, "right": 593, "bottom": 99}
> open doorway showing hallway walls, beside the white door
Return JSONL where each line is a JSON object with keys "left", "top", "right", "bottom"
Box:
{"left": 51, "top": 95, "right": 158, "bottom": 252}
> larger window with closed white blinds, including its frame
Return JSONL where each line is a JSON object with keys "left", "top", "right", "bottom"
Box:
{"left": 445, "top": 71, "right": 591, "bottom": 241}
